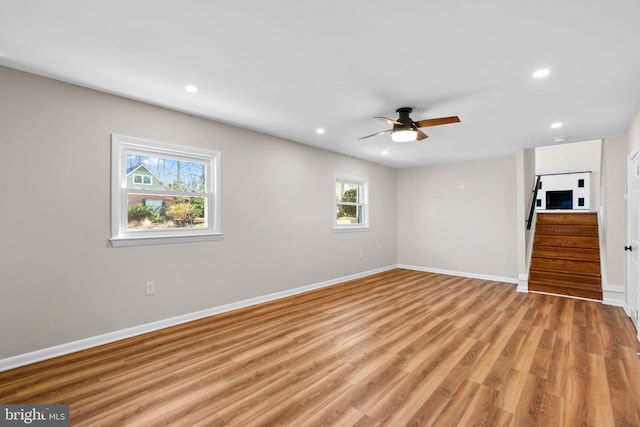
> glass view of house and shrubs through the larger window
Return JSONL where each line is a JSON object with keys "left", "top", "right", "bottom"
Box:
{"left": 126, "top": 153, "right": 206, "bottom": 229}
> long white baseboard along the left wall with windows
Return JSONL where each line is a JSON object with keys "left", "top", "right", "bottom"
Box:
{"left": 0, "top": 265, "right": 397, "bottom": 372}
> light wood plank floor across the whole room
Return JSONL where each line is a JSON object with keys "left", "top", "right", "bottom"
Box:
{"left": 0, "top": 269, "right": 640, "bottom": 427}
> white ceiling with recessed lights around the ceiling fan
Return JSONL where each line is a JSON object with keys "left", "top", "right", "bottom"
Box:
{"left": 0, "top": 0, "right": 640, "bottom": 167}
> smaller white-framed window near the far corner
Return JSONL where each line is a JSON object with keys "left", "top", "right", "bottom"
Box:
{"left": 333, "top": 175, "right": 369, "bottom": 230}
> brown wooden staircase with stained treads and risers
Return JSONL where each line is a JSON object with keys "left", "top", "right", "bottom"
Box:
{"left": 529, "top": 212, "right": 602, "bottom": 300}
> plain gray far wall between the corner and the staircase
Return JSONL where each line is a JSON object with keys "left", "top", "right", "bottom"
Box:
{"left": 398, "top": 156, "right": 518, "bottom": 280}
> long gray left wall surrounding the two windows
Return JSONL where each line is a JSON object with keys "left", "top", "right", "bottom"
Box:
{"left": 0, "top": 68, "right": 397, "bottom": 358}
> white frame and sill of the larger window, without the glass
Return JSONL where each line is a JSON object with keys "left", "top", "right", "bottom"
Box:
{"left": 110, "top": 134, "right": 222, "bottom": 247}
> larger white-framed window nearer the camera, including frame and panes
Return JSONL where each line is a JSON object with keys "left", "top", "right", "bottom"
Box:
{"left": 111, "top": 134, "right": 222, "bottom": 246}
